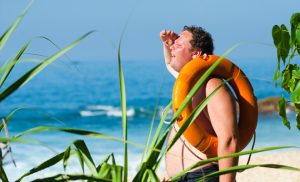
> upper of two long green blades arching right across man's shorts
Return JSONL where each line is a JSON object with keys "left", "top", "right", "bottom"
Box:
{"left": 171, "top": 146, "right": 300, "bottom": 181}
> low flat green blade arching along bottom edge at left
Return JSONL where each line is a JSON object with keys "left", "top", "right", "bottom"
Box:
{"left": 32, "top": 174, "right": 112, "bottom": 182}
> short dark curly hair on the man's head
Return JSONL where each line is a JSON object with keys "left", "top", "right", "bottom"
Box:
{"left": 183, "top": 26, "right": 214, "bottom": 55}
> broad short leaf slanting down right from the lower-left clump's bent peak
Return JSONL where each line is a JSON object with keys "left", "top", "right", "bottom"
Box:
{"left": 74, "top": 140, "right": 98, "bottom": 176}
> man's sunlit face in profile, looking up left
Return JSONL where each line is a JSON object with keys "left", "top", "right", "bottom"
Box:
{"left": 170, "top": 31, "right": 193, "bottom": 72}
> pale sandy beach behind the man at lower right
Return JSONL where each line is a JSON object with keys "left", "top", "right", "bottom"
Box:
{"left": 236, "top": 151, "right": 300, "bottom": 182}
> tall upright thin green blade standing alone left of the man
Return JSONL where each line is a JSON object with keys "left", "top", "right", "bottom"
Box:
{"left": 118, "top": 32, "right": 128, "bottom": 182}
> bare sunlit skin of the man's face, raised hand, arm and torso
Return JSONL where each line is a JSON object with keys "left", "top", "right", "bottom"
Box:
{"left": 160, "top": 30, "right": 238, "bottom": 182}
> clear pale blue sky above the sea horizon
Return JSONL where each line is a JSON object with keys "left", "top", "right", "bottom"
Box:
{"left": 0, "top": 0, "right": 300, "bottom": 60}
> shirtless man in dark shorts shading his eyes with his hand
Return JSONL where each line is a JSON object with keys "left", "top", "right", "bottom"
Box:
{"left": 160, "top": 26, "right": 238, "bottom": 182}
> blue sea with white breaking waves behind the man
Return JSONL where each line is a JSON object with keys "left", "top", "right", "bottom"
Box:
{"left": 0, "top": 58, "right": 300, "bottom": 181}
